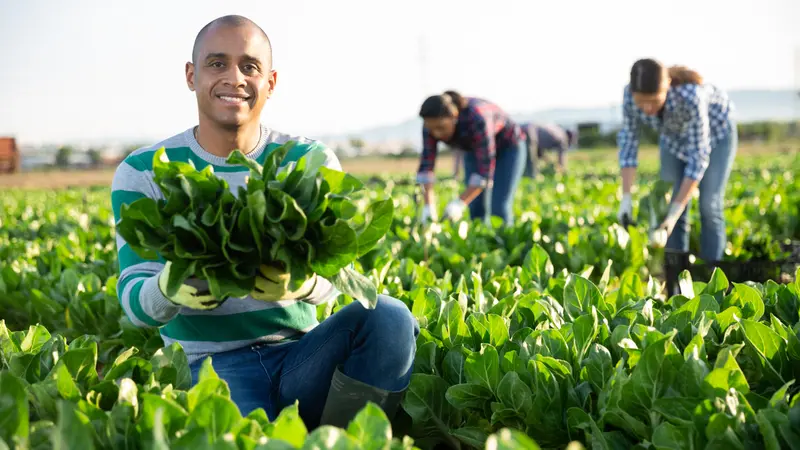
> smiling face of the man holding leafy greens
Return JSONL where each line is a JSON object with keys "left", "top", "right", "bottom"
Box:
{"left": 186, "top": 25, "right": 277, "bottom": 129}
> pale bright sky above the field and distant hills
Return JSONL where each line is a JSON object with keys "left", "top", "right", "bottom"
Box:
{"left": 0, "top": 0, "right": 800, "bottom": 145}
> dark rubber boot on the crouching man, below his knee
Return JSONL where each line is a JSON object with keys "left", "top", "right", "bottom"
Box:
{"left": 320, "top": 367, "right": 405, "bottom": 429}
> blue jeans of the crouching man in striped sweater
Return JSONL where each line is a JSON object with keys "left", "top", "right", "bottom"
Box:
{"left": 190, "top": 295, "right": 419, "bottom": 428}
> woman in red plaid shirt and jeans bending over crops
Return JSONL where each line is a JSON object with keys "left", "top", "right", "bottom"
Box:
{"left": 417, "top": 91, "right": 527, "bottom": 224}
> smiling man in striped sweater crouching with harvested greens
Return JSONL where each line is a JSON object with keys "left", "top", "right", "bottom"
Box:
{"left": 111, "top": 16, "right": 419, "bottom": 428}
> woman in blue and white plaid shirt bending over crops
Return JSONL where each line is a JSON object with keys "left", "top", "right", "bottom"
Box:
{"left": 618, "top": 59, "right": 737, "bottom": 262}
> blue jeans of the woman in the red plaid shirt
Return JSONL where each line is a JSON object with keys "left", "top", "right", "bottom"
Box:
{"left": 464, "top": 139, "right": 528, "bottom": 225}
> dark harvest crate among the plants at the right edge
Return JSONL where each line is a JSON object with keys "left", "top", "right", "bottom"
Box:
{"left": 664, "top": 242, "right": 800, "bottom": 296}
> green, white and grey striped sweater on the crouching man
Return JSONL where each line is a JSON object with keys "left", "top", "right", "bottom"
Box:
{"left": 111, "top": 126, "right": 342, "bottom": 363}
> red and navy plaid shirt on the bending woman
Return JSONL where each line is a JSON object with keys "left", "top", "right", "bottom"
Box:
{"left": 417, "top": 97, "right": 525, "bottom": 187}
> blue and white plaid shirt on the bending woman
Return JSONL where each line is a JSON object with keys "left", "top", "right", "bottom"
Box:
{"left": 617, "top": 84, "right": 734, "bottom": 181}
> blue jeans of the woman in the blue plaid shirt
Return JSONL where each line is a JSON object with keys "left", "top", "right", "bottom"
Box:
{"left": 661, "top": 123, "right": 738, "bottom": 262}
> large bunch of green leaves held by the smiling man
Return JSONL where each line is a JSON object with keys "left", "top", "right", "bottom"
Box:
{"left": 117, "top": 141, "right": 394, "bottom": 306}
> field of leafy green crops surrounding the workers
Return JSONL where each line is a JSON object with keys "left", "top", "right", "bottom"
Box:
{"left": 0, "top": 149, "right": 800, "bottom": 449}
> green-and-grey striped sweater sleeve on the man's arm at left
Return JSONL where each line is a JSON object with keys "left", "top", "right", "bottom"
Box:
{"left": 111, "top": 156, "right": 181, "bottom": 328}
